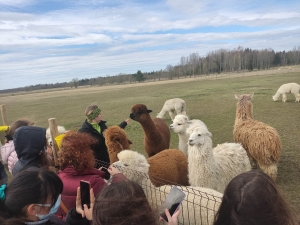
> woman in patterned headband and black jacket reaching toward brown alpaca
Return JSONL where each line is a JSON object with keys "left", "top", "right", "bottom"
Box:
{"left": 79, "top": 105, "right": 129, "bottom": 167}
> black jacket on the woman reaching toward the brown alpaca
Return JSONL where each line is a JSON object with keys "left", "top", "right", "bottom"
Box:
{"left": 79, "top": 120, "right": 127, "bottom": 167}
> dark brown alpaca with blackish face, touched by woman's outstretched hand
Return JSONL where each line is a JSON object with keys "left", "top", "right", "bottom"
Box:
{"left": 130, "top": 104, "right": 171, "bottom": 157}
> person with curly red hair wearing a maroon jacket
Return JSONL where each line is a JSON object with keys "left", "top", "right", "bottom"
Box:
{"left": 56, "top": 131, "right": 126, "bottom": 219}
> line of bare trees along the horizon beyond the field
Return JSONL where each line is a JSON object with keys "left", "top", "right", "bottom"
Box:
{"left": 0, "top": 46, "right": 300, "bottom": 93}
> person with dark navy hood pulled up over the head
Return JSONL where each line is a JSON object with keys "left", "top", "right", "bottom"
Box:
{"left": 12, "top": 126, "right": 50, "bottom": 176}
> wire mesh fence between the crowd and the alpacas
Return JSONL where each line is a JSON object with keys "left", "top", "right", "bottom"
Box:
{"left": 96, "top": 161, "right": 222, "bottom": 225}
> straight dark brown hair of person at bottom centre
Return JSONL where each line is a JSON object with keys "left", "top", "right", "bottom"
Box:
{"left": 93, "top": 180, "right": 158, "bottom": 225}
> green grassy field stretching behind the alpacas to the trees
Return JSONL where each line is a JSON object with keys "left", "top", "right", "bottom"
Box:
{"left": 0, "top": 71, "right": 300, "bottom": 215}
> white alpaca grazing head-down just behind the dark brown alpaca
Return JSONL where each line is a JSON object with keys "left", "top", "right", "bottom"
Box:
{"left": 156, "top": 98, "right": 186, "bottom": 120}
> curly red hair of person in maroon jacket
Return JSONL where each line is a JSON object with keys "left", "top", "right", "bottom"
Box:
{"left": 58, "top": 131, "right": 97, "bottom": 171}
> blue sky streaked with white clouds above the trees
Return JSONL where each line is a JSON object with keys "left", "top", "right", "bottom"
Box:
{"left": 0, "top": 0, "right": 300, "bottom": 90}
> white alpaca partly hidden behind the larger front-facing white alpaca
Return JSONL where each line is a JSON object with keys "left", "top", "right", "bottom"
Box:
{"left": 170, "top": 115, "right": 207, "bottom": 156}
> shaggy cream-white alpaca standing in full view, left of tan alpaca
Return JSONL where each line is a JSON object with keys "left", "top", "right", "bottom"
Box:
{"left": 187, "top": 127, "right": 251, "bottom": 193}
